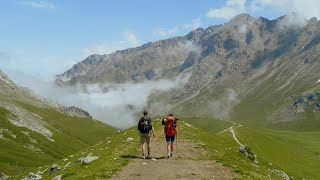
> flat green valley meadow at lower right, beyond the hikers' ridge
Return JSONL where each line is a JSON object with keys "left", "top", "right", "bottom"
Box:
{"left": 186, "top": 118, "right": 320, "bottom": 179}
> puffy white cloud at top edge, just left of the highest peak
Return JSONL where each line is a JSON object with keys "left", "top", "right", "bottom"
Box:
{"left": 207, "top": 0, "right": 247, "bottom": 19}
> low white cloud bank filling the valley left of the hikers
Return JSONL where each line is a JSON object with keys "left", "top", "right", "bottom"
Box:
{"left": 9, "top": 69, "right": 190, "bottom": 128}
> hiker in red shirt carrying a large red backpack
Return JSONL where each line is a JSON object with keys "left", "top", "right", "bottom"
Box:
{"left": 162, "top": 114, "right": 178, "bottom": 159}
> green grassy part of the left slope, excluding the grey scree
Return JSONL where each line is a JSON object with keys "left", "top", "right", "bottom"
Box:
{"left": 0, "top": 103, "right": 116, "bottom": 177}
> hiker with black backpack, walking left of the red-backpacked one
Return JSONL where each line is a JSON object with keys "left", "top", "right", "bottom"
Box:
{"left": 138, "top": 110, "right": 156, "bottom": 159}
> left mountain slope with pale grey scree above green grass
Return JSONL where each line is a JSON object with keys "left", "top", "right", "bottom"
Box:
{"left": 0, "top": 71, "right": 116, "bottom": 178}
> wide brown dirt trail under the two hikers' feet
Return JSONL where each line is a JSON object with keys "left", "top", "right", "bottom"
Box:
{"left": 112, "top": 127, "right": 237, "bottom": 179}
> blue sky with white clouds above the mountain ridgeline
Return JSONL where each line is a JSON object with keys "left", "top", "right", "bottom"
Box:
{"left": 0, "top": 0, "right": 319, "bottom": 78}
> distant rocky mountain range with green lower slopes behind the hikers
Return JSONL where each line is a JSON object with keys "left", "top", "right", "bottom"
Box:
{"left": 56, "top": 13, "right": 320, "bottom": 129}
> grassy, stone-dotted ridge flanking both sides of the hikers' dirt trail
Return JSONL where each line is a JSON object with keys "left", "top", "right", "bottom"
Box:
{"left": 24, "top": 119, "right": 292, "bottom": 179}
